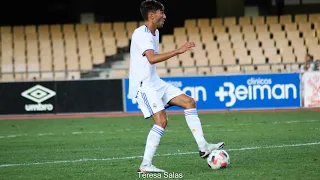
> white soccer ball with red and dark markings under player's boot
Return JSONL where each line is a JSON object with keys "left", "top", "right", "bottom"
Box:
{"left": 207, "top": 150, "right": 230, "bottom": 169}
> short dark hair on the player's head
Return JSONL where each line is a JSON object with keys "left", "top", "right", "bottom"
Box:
{"left": 140, "top": 0, "right": 164, "bottom": 21}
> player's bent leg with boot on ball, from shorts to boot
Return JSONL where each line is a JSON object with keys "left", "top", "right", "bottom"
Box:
{"left": 164, "top": 86, "right": 224, "bottom": 158}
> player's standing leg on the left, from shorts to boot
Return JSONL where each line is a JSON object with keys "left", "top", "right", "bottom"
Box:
{"left": 137, "top": 90, "right": 167, "bottom": 172}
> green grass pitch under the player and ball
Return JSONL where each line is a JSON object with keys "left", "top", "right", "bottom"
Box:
{"left": 0, "top": 111, "right": 320, "bottom": 180}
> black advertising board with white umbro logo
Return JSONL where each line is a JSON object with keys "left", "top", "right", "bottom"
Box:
{"left": 0, "top": 79, "right": 123, "bottom": 114}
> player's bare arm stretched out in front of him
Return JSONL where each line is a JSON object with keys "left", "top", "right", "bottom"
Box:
{"left": 143, "top": 42, "right": 195, "bottom": 64}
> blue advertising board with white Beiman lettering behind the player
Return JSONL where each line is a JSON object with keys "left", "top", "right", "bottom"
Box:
{"left": 124, "top": 73, "right": 300, "bottom": 112}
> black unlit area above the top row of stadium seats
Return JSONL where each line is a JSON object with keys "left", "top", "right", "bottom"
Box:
{"left": 0, "top": 0, "right": 320, "bottom": 34}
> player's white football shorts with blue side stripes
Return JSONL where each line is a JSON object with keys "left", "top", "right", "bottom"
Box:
{"left": 136, "top": 84, "right": 183, "bottom": 119}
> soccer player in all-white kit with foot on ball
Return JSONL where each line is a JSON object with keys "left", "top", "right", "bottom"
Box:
{"left": 128, "top": 0, "right": 224, "bottom": 173}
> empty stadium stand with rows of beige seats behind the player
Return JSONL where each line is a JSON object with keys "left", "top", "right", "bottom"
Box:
{"left": 0, "top": 14, "right": 320, "bottom": 81}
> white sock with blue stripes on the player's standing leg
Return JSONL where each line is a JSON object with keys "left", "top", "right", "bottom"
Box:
{"left": 141, "top": 124, "right": 164, "bottom": 165}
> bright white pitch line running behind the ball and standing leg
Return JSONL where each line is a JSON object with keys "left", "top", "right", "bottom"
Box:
{"left": 0, "top": 142, "right": 320, "bottom": 168}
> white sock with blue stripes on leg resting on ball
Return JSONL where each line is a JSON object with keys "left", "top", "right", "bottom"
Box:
{"left": 184, "top": 108, "right": 207, "bottom": 150}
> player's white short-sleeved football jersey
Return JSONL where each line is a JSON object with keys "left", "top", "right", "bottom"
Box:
{"left": 128, "top": 25, "right": 165, "bottom": 98}
